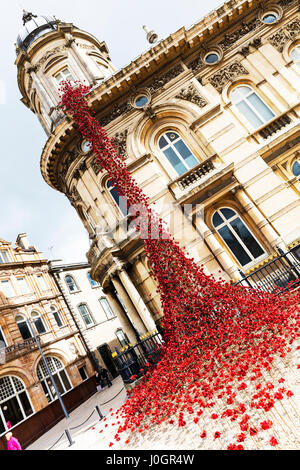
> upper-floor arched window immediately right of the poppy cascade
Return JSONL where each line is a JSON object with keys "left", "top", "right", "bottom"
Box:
{"left": 158, "top": 131, "right": 199, "bottom": 176}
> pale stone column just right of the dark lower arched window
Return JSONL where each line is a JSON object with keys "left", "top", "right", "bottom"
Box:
{"left": 233, "top": 188, "right": 285, "bottom": 249}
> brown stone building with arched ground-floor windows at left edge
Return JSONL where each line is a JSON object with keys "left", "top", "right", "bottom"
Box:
{"left": 0, "top": 233, "right": 95, "bottom": 448}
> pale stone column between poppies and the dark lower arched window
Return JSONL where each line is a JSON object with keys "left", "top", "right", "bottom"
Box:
{"left": 196, "top": 217, "right": 241, "bottom": 279}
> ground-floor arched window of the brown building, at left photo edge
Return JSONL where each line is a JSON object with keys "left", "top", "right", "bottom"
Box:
{"left": 0, "top": 375, "right": 33, "bottom": 434}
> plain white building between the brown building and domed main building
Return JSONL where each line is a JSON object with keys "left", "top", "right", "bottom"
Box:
{"left": 49, "top": 261, "right": 128, "bottom": 378}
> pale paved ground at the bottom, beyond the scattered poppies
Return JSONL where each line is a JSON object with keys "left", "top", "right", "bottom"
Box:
{"left": 28, "top": 349, "right": 300, "bottom": 451}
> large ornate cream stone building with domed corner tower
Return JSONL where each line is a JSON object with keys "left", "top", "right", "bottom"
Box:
{"left": 16, "top": 0, "right": 300, "bottom": 339}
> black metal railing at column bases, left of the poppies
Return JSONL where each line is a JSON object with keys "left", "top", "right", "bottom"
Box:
{"left": 112, "top": 332, "right": 163, "bottom": 384}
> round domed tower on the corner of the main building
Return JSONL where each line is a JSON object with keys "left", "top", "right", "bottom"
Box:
{"left": 16, "top": 10, "right": 115, "bottom": 136}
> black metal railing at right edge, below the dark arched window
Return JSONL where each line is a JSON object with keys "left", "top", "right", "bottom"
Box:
{"left": 235, "top": 243, "right": 300, "bottom": 293}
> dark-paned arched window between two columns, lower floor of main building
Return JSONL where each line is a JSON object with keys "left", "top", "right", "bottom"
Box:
{"left": 212, "top": 207, "right": 265, "bottom": 266}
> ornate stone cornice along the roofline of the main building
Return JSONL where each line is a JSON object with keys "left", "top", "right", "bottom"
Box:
{"left": 41, "top": 0, "right": 296, "bottom": 191}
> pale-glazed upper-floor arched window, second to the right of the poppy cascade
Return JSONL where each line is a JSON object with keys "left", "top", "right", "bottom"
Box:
{"left": 230, "top": 85, "right": 275, "bottom": 129}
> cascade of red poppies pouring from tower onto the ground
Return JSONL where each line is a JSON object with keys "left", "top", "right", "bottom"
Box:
{"left": 61, "top": 82, "right": 300, "bottom": 449}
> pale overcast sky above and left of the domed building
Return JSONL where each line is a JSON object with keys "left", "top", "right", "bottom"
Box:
{"left": 0, "top": 0, "right": 223, "bottom": 262}
